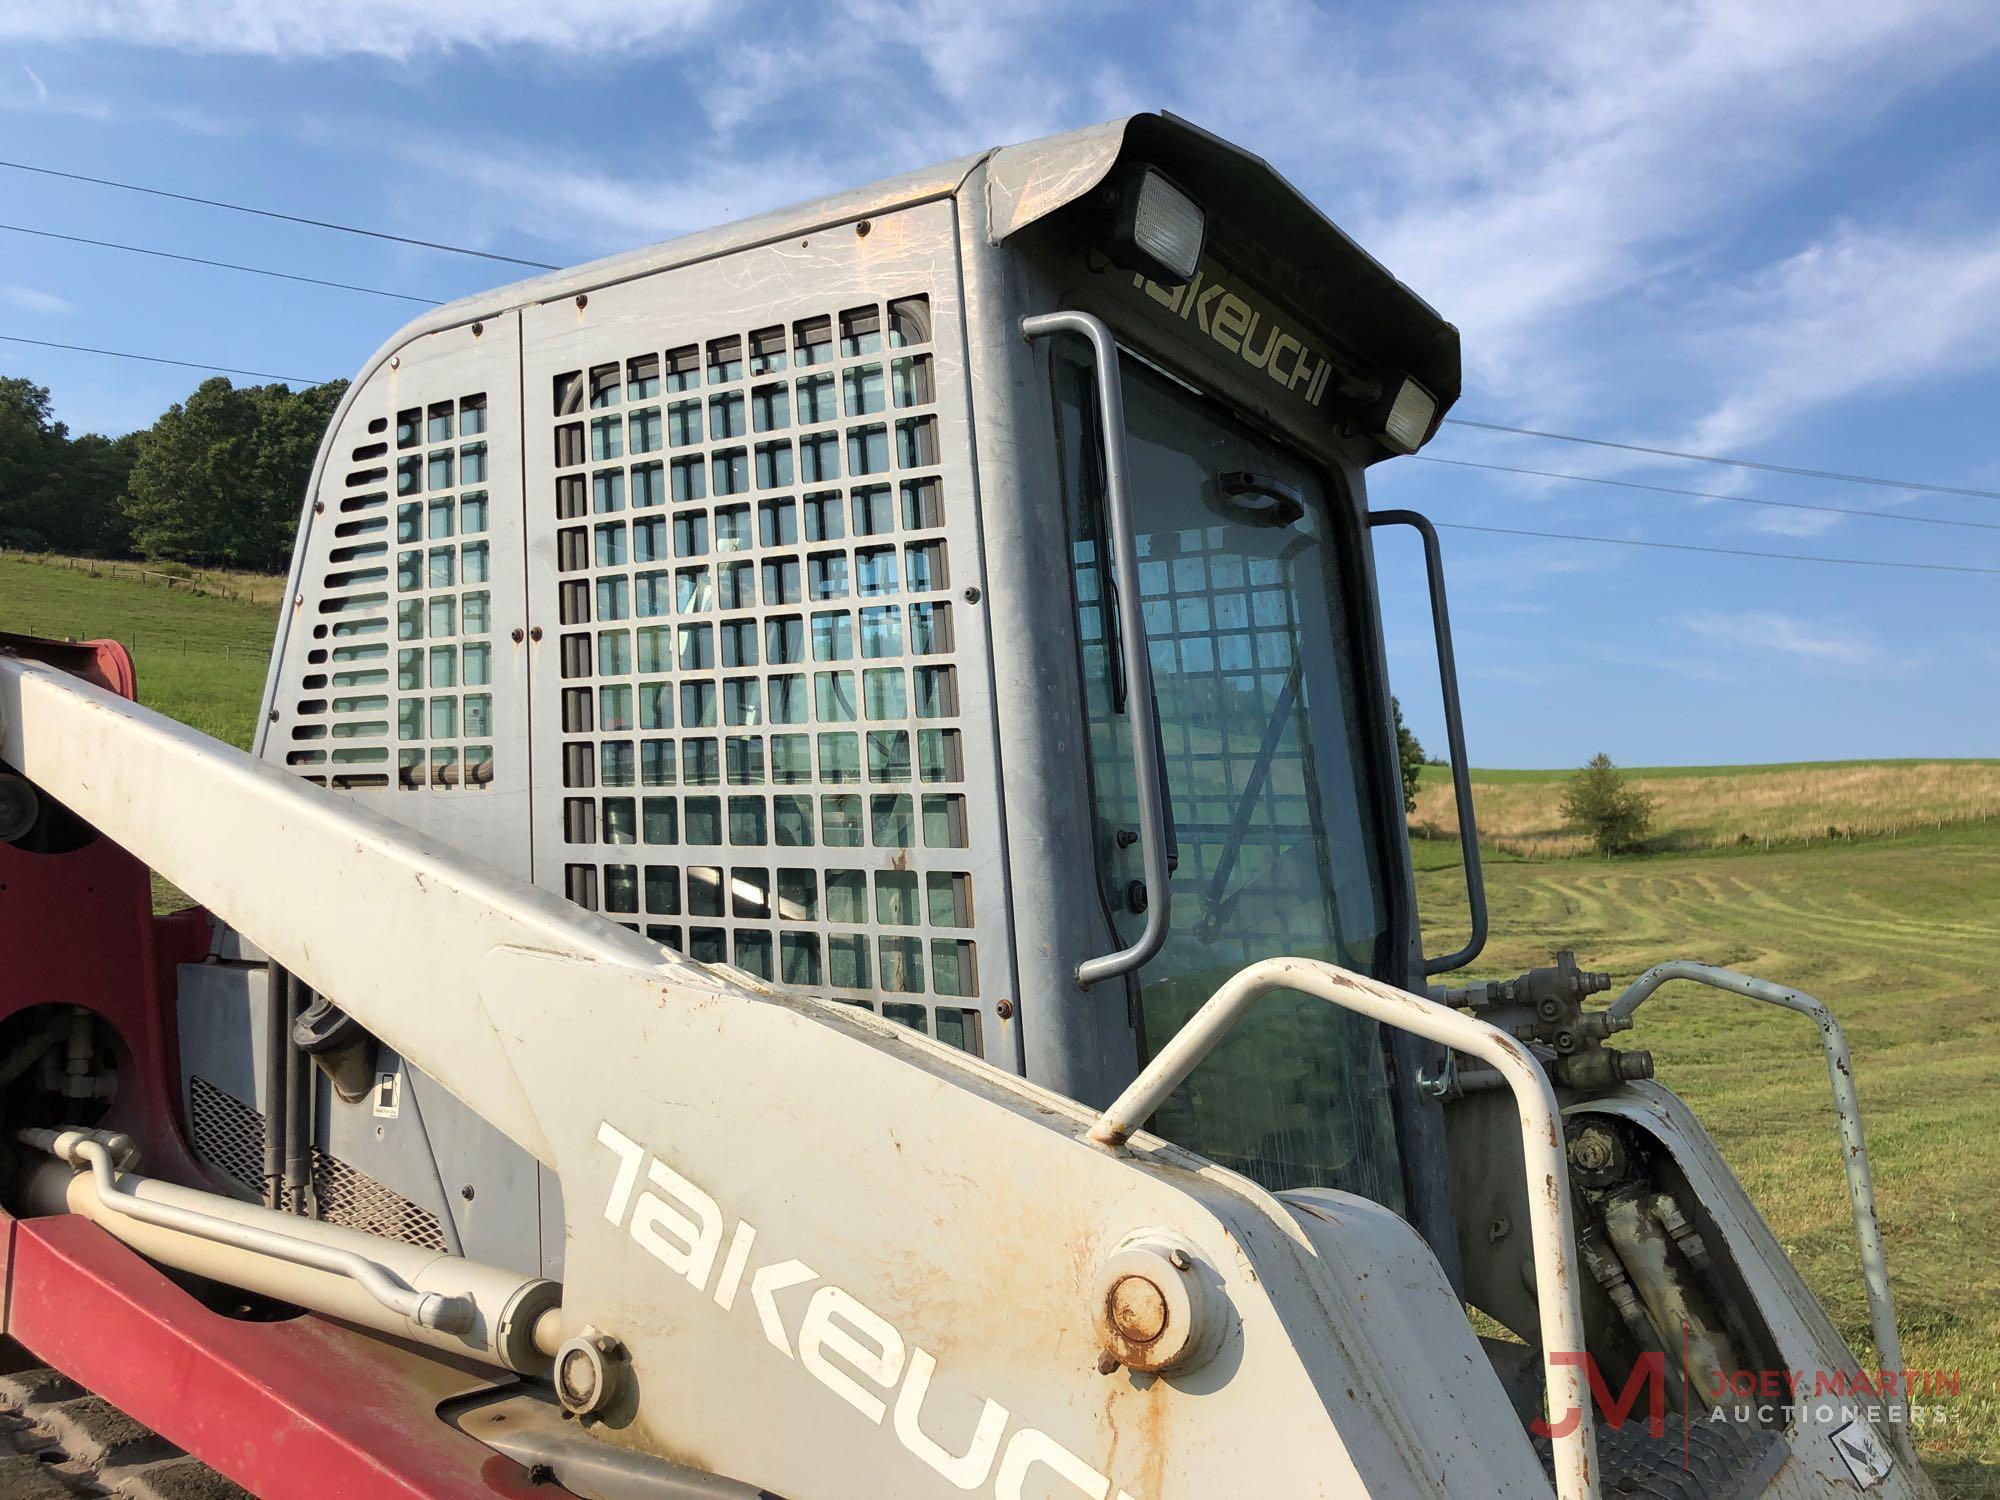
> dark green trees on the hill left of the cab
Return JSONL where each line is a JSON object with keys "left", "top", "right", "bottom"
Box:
{"left": 0, "top": 376, "right": 348, "bottom": 572}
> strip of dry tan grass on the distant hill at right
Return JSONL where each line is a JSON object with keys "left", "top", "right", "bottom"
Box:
{"left": 1410, "top": 760, "right": 2000, "bottom": 858}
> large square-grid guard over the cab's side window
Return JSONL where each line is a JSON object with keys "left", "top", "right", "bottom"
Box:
{"left": 530, "top": 296, "right": 1000, "bottom": 1052}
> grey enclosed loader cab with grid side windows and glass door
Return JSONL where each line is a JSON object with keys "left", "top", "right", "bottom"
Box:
{"left": 246, "top": 116, "right": 1458, "bottom": 1272}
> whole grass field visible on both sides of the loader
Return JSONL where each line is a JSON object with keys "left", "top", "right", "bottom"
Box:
{"left": 0, "top": 558, "right": 2000, "bottom": 1498}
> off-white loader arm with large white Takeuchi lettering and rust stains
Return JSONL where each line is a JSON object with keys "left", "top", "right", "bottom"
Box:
{"left": 0, "top": 658, "right": 1560, "bottom": 1500}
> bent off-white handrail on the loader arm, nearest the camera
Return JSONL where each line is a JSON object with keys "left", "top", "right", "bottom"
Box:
{"left": 1090, "top": 958, "right": 1598, "bottom": 1500}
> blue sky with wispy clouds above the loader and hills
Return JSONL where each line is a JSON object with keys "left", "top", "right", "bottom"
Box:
{"left": 0, "top": 0, "right": 2000, "bottom": 766}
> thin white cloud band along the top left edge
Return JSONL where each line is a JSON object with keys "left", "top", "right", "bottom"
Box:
{"left": 0, "top": 0, "right": 722, "bottom": 60}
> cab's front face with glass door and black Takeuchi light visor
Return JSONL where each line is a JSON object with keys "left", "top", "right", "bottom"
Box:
{"left": 988, "top": 118, "right": 1458, "bottom": 1232}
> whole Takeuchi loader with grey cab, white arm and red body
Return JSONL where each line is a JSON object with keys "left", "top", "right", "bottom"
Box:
{"left": 0, "top": 116, "right": 1932, "bottom": 1500}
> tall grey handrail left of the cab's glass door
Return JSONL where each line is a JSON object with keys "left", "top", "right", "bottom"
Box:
{"left": 1020, "top": 312, "right": 1174, "bottom": 990}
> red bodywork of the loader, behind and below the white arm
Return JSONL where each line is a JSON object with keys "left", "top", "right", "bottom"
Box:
{"left": 0, "top": 636, "right": 568, "bottom": 1500}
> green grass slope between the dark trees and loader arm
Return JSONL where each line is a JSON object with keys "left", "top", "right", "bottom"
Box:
{"left": 0, "top": 556, "right": 278, "bottom": 746}
